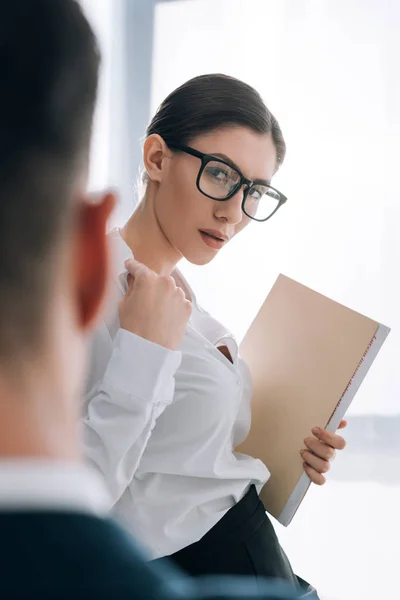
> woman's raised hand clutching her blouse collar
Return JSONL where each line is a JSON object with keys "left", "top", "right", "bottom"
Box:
{"left": 119, "top": 259, "right": 192, "bottom": 350}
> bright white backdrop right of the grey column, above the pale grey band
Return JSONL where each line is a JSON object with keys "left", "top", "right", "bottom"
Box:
{"left": 153, "top": 0, "right": 400, "bottom": 414}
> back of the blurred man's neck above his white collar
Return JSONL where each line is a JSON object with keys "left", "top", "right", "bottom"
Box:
{"left": 0, "top": 356, "right": 79, "bottom": 462}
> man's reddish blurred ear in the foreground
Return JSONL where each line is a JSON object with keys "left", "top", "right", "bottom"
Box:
{"left": 73, "top": 193, "right": 116, "bottom": 330}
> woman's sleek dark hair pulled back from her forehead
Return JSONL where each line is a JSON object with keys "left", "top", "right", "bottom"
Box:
{"left": 146, "top": 74, "right": 286, "bottom": 168}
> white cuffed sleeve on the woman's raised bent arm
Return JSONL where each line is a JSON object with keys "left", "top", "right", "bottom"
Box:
{"left": 83, "top": 323, "right": 181, "bottom": 505}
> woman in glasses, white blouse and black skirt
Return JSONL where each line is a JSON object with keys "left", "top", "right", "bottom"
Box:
{"left": 84, "top": 75, "right": 344, "bottom": 589}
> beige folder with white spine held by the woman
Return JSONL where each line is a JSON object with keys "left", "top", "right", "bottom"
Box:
{"left": 236, "top": 275, "right": 390, "bottom": 525}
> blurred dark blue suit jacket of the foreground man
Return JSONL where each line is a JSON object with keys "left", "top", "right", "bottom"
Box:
{"left": 0, "top": 510, "right": 313, "bottom": 600}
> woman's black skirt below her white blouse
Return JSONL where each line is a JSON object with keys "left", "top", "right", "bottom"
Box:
{"left": 154, "top": 486, "right": 317, "bottom": 598}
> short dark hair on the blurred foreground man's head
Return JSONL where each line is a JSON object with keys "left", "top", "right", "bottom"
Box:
{"left": 0, "top": 0, "right": 100, "bottom": 359}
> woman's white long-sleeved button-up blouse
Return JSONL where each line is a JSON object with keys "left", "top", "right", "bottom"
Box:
{"left": 83, "top": 230, "right": 269, "bottom": 558}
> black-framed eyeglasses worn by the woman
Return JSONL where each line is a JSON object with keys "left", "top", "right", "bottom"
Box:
{"left": 168, "top": 144, "right": 287, "bottom": 222}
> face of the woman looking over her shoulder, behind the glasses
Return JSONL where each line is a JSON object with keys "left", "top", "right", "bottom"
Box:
{"left": 148, "top": 126, "right": 276, "bottom": 265}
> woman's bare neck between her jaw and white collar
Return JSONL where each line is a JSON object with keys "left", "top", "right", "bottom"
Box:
{"left": 121, "top": 189, "right": 182, "bottom": 275}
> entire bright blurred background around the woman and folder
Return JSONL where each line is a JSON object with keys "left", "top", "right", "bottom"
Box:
{"left": 82, "top": 0, "right": 400, "bottom": 600}
